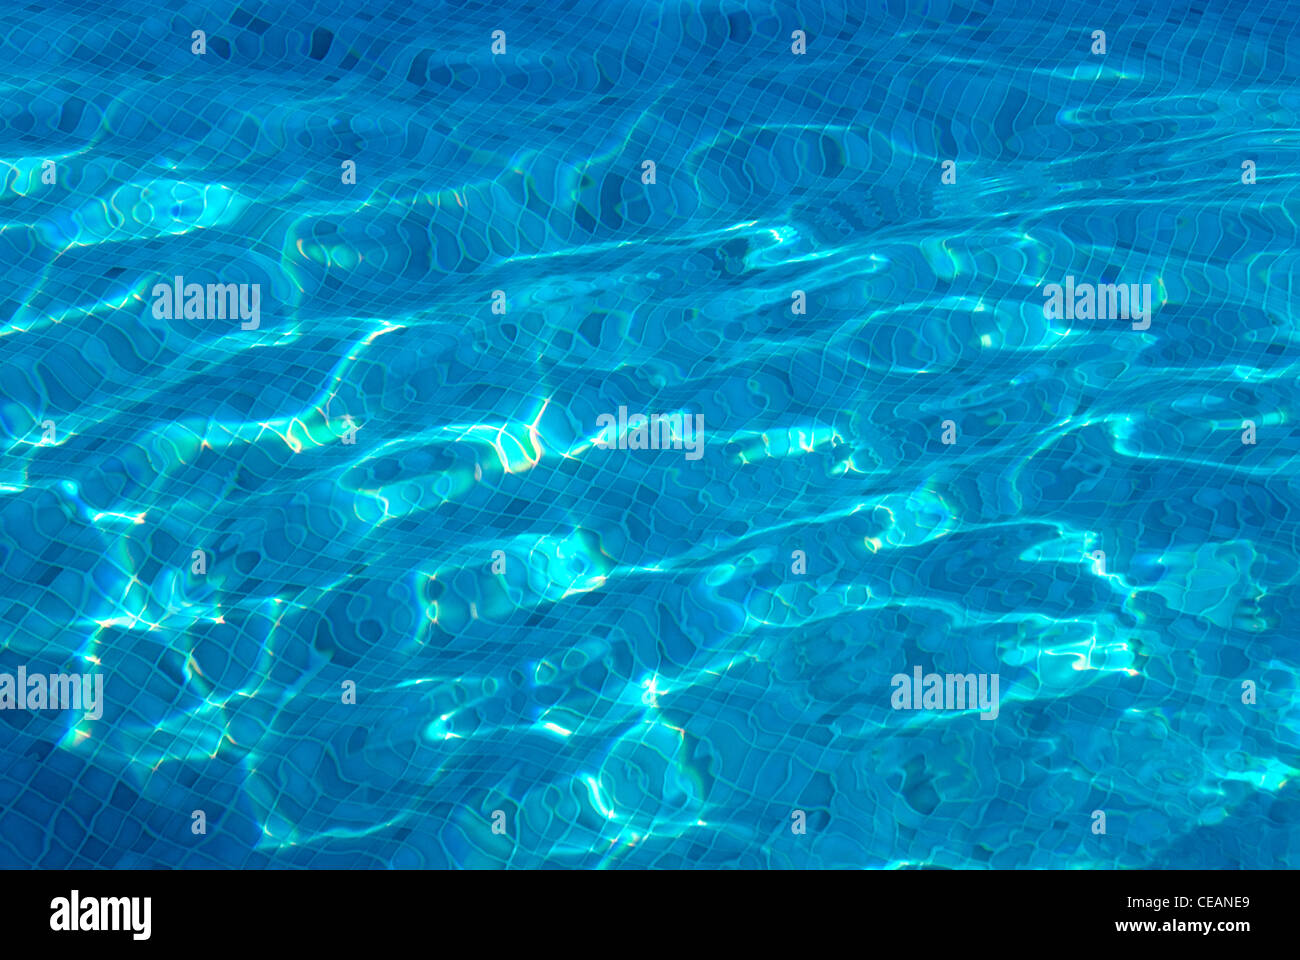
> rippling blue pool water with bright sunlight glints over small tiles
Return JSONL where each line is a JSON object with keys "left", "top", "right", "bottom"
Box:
{"left": 0, "top": 0, "right": 1300, "bottom": 868}
